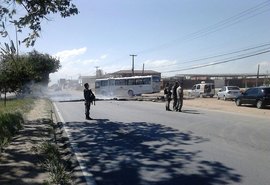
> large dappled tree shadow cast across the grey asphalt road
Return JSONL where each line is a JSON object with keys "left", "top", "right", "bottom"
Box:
{"left": 66, "top": 119, "right": 241, "bottom": 185}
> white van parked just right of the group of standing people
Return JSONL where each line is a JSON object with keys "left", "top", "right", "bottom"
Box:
{"left": 189, "top": 81, "right": 215, "bottom": 98}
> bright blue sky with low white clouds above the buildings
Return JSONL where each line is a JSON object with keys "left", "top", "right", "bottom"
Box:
{"left": 2, "top": 0, "right": 270, "bottom": 82}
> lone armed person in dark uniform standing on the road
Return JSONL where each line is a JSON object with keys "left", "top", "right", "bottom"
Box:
{"left": 83, "top": 83, "right": 95, "bottom": 120}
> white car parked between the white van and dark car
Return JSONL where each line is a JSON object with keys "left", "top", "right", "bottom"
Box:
{"left": 217, "top": 86, "right": 241, "bottom": 100}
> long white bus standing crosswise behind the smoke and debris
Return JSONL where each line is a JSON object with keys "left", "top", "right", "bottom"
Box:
{"left": 95, "top": 76, "right": 160, "bottom": 97}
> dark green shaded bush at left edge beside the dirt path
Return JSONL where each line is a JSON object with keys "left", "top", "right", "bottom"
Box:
{"left": 0, "top": 112, "right": 24, "bottom": 153}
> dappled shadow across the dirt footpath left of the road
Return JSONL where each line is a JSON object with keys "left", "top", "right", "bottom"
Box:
{"left": 0, "top": 119, "right": 50, "bottom": 185}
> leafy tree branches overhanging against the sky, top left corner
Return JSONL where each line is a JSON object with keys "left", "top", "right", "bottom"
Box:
{"left": 0, "top": 0, "right": 79, "bottom": 47}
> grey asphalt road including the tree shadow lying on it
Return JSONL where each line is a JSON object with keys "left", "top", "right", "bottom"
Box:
{"left": 55, "top": 101, "right": 270, "bottom": 185}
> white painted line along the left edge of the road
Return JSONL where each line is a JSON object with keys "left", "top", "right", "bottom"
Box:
{"left": 53, "top": 102, "right": 96, "bottom": 185}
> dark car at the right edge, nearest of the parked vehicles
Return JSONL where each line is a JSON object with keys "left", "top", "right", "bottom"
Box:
{"left": 235, "top": 87, "right": 270, "bottom": 109}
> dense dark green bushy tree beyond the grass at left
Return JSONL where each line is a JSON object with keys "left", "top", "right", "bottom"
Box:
{"left": 0, "top": 50, "right": 61, "bottom": 96}
